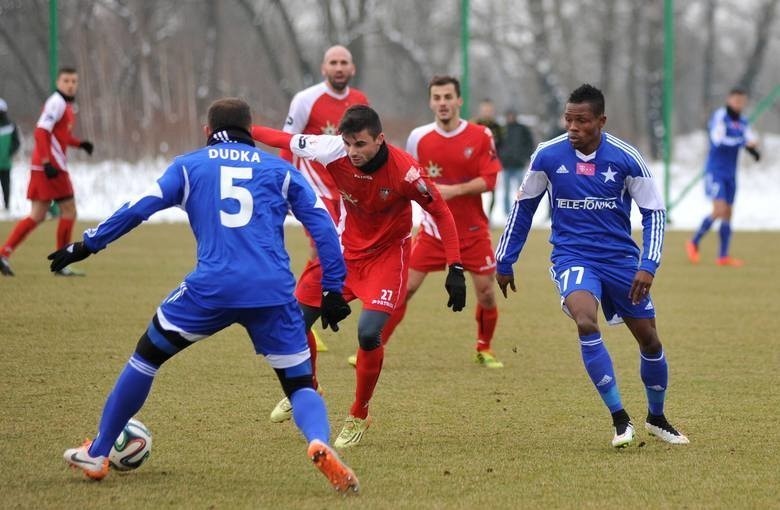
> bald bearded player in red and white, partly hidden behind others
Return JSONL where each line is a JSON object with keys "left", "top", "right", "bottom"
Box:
{"left": 282, "top": 45, "right": 368, "bottom": 354}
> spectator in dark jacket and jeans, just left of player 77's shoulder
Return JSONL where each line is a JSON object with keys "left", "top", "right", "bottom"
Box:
{"left": 498, "top": 109, "right": 534, "bottom": 216}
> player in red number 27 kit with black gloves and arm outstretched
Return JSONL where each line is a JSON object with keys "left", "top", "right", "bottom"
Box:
{"left": 252, "top": 105, "right": 466, "bottom": 448}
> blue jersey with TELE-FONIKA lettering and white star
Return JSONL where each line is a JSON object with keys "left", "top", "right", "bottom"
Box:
{"left": 496, "top": 133, "right": 666, "bottom": 274}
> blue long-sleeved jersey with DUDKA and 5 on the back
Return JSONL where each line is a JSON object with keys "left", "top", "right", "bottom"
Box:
{"left": 84, "top": 135, "right": 346, "bottom": 308}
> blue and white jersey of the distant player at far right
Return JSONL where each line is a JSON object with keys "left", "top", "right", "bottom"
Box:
{"left": 706, "top": 106, "right": 755, "bottom": 179}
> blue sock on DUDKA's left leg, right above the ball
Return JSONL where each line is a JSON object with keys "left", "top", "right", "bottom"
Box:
{"left": 89, "top": 354, "right": 160, "bottom": 457}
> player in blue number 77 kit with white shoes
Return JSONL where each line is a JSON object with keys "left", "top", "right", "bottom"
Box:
{"left": 496, "top": 85, "right": 688, "bottom": 448}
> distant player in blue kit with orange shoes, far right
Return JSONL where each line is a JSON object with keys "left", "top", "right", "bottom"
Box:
{"left": 685, "top": 88, "right": 761, "bottom": 267}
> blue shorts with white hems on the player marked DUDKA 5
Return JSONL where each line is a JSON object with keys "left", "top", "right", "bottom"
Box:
{"left": 152, "top": 283, "right": 310, "bottom": 368}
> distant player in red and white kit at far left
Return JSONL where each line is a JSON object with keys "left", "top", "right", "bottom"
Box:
{"left": 0, "top": 67, "right": 93, "bottom": 276}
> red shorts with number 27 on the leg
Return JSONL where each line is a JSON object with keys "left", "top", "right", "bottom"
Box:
{"left": 295, "top": 239, "right": 411, "bottom": 313}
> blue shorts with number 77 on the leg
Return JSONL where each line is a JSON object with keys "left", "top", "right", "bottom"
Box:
{"left": 550, "top": 257, "right": 655, "bottom": 324}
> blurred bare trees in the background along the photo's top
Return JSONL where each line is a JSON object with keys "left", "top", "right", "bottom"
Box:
{"left": 0, "top": 0, "right": 780, "bottom": 161}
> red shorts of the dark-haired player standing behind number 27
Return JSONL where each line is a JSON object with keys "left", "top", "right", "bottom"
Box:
{"left": 409, "top": 231, "right": 496, "bottom": 274}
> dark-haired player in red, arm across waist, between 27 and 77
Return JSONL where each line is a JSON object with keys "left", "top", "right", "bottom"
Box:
{"left": 382, "top": 76, "right": 504, "bottom": 368}
